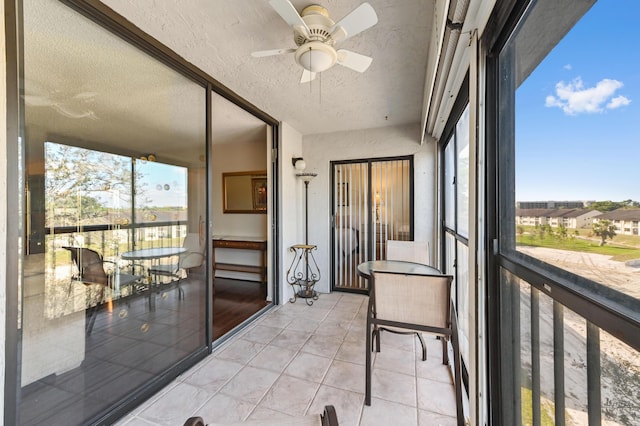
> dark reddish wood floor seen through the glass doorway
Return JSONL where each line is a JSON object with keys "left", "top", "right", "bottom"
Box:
{"left": 213, "top": 278, "right": 269, "bottom": 340}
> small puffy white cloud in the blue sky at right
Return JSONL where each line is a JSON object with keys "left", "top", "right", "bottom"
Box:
{"left": 545, "top": 77, "right": 631, "bottom": 115}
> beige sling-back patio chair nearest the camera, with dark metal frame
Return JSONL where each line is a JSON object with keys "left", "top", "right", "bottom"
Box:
{"left": 365, "top": 270, "right": 464, "bottom": 425}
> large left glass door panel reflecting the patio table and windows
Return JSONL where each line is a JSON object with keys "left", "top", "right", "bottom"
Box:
{"left": 17, "top": 0, "right": 207, "bottom": 425}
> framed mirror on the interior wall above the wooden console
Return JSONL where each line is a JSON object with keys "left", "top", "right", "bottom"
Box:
{"left": 222, "top": 170, "right": 267, "bottom": 213}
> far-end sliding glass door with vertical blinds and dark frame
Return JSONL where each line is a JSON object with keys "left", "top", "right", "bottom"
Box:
{"left": 331, "top": 157, "right": 413, "bottom": 292}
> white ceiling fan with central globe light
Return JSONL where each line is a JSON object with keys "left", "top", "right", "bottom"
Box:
{"left": 251, "top": 0, "right": 378, "bottom": 83}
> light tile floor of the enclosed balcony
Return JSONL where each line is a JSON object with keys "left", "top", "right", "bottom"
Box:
{"left": 119, "top": 293, "right": 456, "bottom": 426}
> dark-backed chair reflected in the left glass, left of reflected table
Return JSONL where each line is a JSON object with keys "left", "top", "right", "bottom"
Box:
{"left": 62, "top": 246, "right": 143, "bottom": 336}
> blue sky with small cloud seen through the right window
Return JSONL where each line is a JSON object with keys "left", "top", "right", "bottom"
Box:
{"left": 516, "top": 0, "right": 640, "bottom": 201}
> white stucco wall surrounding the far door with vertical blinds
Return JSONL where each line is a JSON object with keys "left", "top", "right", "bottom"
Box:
{"left": 302, "top": 121, "right": 436, "bottom": 292}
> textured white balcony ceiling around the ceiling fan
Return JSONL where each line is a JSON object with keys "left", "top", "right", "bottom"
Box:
{"left": 103, "top": 0, "right": 435, "bottom": 135}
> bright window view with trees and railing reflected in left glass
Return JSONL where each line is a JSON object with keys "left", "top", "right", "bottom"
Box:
{"left": 39, "top": 142, "right": 188, "bottom": 319}
